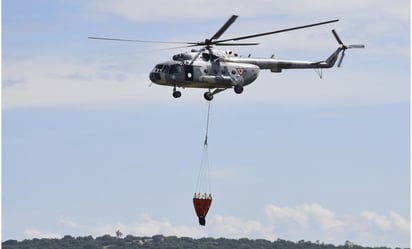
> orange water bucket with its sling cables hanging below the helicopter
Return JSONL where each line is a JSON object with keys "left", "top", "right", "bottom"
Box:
{"left": 193, "top": 101, "right": 212, "bottom": 226}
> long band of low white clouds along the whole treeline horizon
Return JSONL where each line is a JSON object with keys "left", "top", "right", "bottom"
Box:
{"left": 49, "top": 203, "right": 410, "bottom": 247}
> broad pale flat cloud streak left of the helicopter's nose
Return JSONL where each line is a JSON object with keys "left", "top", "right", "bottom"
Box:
{"left": 2, "top": 55, "right": 171, "bottom": 109}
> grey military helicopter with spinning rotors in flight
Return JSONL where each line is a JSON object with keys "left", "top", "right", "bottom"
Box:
{"left": 88, "top": 15, "right": 365, "bottom": 101}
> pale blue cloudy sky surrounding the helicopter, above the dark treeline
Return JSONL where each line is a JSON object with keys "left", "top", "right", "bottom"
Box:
{"left": 2, "top": 0, "right": 410, "bottom": 247}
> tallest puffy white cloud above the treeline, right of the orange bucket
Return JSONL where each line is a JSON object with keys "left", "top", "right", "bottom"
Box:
{"left": 265, "top": 203, "right": 410, "bottom": 246}
